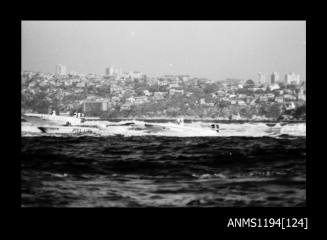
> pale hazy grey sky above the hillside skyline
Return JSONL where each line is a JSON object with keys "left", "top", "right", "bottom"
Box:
{"left": 22, "top": 21, "right": 306, "bottom": 80}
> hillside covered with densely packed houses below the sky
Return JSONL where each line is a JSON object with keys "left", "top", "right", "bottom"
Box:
{"left": 21, "top": 71, "right": 306, "bottom": 118}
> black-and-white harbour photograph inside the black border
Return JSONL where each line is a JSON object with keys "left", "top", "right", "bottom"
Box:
{"left": 20, "top": 20, "right": 307, "bottom": 208}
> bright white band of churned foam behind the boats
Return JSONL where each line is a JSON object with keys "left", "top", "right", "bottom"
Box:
{"left": 21, "top": 121, "right": 306, "bottom": 138}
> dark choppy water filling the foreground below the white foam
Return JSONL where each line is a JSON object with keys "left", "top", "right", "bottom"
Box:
{"left": 21, "top": 136, "right": 306, "bottom": 207}
